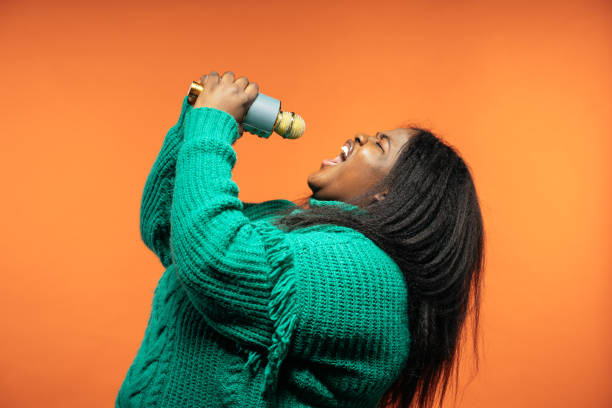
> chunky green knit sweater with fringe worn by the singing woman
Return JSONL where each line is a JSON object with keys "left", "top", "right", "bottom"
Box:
{"left": 115, "top": 97, "right": 410, "bottom": 408}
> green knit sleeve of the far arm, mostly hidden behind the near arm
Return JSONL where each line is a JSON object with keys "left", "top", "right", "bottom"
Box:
{"left": 140, "top": 96, "right": 193, "bottom": 267}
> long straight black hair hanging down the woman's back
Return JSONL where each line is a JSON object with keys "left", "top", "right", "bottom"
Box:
{"left": 275, "top": 126, "right": 484, "bottom": 408}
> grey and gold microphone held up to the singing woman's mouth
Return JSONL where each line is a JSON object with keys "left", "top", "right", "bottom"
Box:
{"left": 184, "top": 81, "right": 306, "bottom": 139}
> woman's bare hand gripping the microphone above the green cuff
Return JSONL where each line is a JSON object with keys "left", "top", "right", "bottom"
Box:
{"left": 193, "top": 71, "right": 259, "bottom": 136}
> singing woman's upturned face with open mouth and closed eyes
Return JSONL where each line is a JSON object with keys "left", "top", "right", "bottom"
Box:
{"left": 308, "top": 128, "right": 413, "bottom": 202}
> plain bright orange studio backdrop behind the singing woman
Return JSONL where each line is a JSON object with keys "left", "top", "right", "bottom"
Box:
{"left": 0, "top": 0, "right": 612, "bottom": 407}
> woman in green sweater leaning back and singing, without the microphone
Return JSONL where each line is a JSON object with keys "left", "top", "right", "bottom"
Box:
{"left": 116, "top": 71, "right": 484, "bottom": 408}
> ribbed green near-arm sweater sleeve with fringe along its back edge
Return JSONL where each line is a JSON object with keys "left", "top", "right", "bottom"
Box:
{"left": 170, "top": 107, "right": 297, "bottom": 391}
